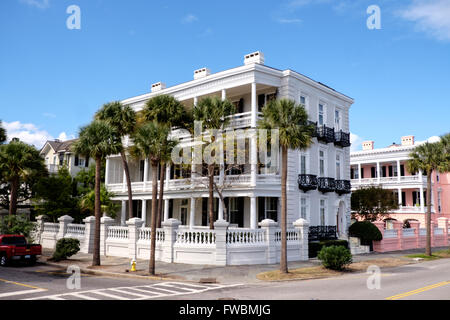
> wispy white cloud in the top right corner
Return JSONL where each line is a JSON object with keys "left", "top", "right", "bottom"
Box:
{"left": 398, "top": 0, "right": 450, "bottom": 40}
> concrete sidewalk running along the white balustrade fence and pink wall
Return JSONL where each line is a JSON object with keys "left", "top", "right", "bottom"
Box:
{"left": 39, "top": 247, "right": 447, "bottom": 284}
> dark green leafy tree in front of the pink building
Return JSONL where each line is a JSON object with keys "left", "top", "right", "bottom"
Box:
{"left": 351, "top": 186, "right": 398, "bottom": 221}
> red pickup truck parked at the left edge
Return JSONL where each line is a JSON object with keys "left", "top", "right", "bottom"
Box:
{"left": 0, "top": 234, "right": 42, "bottom": 267}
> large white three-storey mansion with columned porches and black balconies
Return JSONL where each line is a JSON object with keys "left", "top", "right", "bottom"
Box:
{"left": 106, "top": 52, "right": 353, "bottom": 236}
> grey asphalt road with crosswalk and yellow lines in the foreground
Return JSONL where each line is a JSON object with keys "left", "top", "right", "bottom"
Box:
{"left": 0, "top": 259, "right": 450, "bottom": 300}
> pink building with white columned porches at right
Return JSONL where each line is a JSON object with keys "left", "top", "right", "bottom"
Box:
{"left": 350, "top": 136, "right": 450, "bottom": 229}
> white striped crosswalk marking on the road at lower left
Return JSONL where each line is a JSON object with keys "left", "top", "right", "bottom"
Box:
{"left": 26, "top": 282, "right": 242, "bottom": 300}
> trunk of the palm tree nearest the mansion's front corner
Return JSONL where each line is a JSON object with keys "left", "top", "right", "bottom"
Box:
{"left": 280, "top": 146, "right": 288, "bottom": 273}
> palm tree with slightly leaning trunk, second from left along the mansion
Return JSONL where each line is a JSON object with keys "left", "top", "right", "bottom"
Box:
{"left": 95, "top": 101, "right": 136, "bottom": 217}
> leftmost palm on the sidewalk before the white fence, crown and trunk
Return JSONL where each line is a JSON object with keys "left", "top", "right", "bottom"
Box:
{"left": 72, "top": 120, "right": 123, "bottom": 266}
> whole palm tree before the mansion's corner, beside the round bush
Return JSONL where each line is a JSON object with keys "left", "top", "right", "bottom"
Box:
{"left": 258, "top": 99, "right": 314, "bottom": 273}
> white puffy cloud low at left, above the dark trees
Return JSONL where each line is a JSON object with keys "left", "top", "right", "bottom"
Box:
{"left": 3, "top": 121, "right": 73, "bottom": 148}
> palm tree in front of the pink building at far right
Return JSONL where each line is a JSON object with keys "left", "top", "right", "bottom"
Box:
{"left": 406, "top": 142, "right": 446, "bottom": 256}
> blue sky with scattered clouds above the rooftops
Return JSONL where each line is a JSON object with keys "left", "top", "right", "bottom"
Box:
{"left": 0, "top": 0, "right": 450, "bottom": 149}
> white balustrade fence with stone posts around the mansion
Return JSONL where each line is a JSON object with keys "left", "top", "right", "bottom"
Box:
{"left": 34, "top": 216, "right": 308, "bottom": 265}
